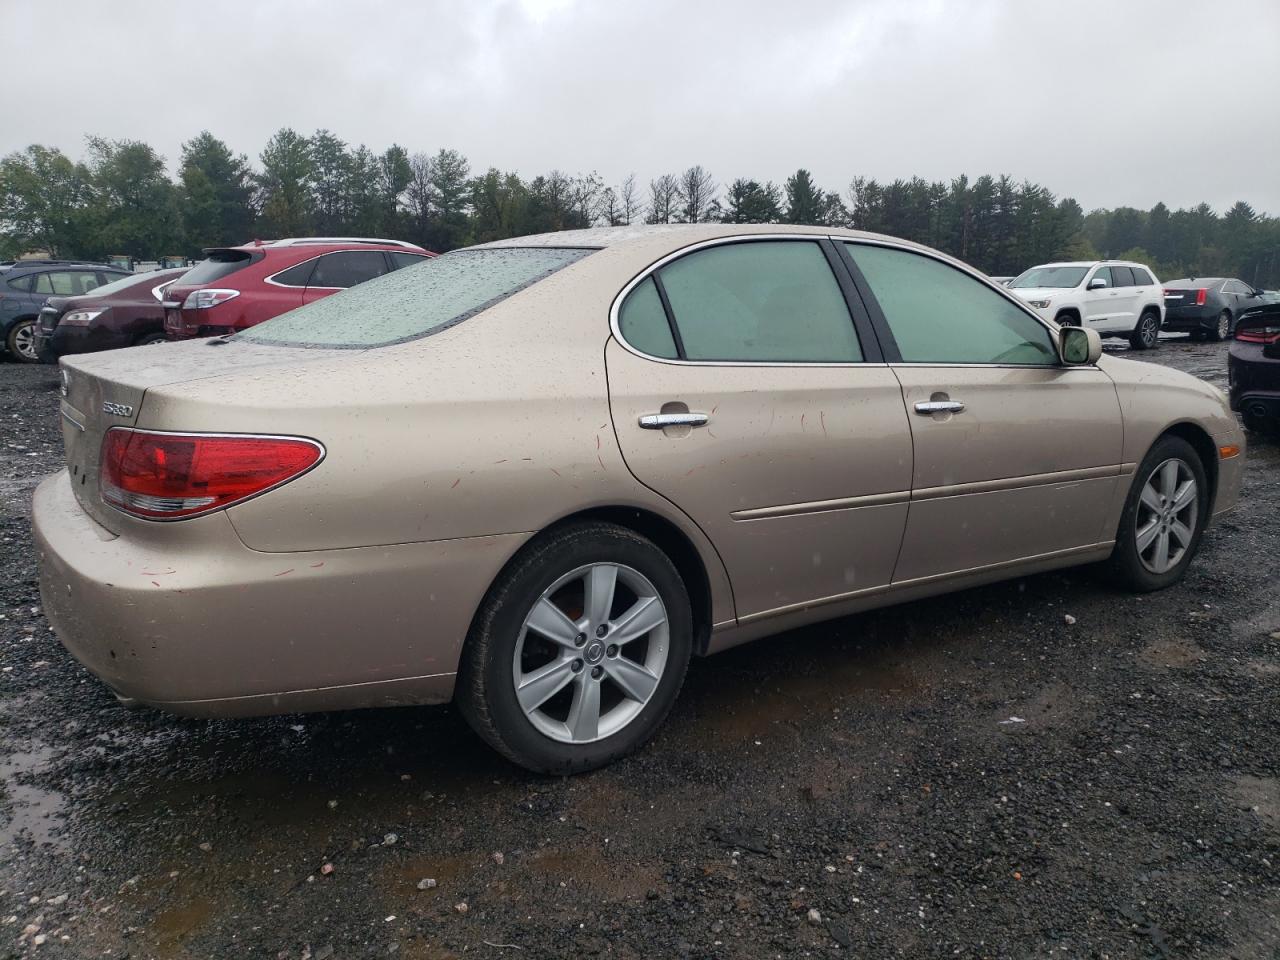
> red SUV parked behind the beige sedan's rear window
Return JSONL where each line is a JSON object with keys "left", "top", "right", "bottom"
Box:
{"left": 164, "top": 237, "right": 435, "bottom": 340}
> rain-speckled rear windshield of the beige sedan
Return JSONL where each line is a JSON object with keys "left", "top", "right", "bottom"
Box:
{"left": 236, "top": 247, "right": 591, "bottom": 348}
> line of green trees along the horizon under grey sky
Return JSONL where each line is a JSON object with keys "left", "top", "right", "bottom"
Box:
{"left": 0, "top": 128, "right": 1280, "bottom": 287}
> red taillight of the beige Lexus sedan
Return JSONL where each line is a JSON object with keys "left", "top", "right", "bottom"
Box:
{"left": 99, "top": 426, "right": 324, "bottom": 520}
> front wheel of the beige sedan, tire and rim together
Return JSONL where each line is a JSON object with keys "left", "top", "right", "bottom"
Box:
{"left": 1111, "top": 436, "right": 1210, "bottom": 593}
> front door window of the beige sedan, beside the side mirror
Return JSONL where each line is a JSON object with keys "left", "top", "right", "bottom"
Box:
{"left": 846, "top": 243, "right": 1057, "bottom": 366}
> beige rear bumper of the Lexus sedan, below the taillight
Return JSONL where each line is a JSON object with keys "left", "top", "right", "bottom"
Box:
{"left": 32, "top": 471, "right": 529, "bottom": 717}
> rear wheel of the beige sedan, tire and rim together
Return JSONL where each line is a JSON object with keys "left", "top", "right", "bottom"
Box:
{"left": 457, "top": 524, "right": 692, "bottom": 774}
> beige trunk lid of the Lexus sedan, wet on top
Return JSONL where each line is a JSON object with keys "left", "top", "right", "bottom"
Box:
{"left": 60, "top": 340, "right": 332, "bottom": 532}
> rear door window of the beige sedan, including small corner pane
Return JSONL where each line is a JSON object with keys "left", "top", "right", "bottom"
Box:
{"left": 650, "top": 241, "right": 863, "bottom": 364}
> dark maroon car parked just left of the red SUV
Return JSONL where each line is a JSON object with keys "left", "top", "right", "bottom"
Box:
{"left": 36, "top": 268, "right": 187, "bottom": 364}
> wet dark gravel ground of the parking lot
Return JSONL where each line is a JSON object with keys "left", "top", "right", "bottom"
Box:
{"left": 0, "top": 338, "right": 1280, "bottom": 960}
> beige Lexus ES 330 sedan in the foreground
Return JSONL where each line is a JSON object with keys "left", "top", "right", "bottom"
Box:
{"left": 35, "top": 224, "right": 1244, "bottom": 772}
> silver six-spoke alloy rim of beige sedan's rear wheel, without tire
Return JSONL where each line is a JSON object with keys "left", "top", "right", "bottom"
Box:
{"left": 512, "top": 563, "right": 671, "bottom": 744}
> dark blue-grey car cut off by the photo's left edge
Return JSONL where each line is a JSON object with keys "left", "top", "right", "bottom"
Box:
{"left": 0, "top": 260, "right": 129, "bottom": 364}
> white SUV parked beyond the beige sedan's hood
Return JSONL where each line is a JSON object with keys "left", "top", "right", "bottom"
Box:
{"left": 1009, "top": 260, "right": 1165, "bottom": 349}
